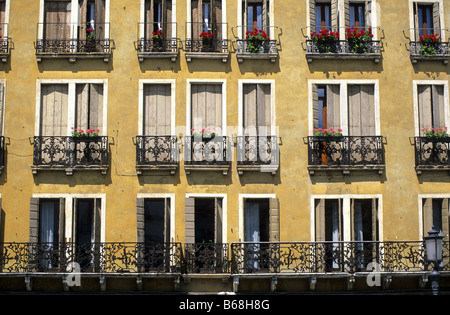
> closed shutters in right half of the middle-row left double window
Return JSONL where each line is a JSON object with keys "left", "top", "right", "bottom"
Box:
{"left": 76, "top": 83, "right": 103, "bottom": 132}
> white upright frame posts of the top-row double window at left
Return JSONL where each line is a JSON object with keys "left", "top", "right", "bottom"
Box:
{"left": 38, "top": 0, "right": 111, "bottom": 40}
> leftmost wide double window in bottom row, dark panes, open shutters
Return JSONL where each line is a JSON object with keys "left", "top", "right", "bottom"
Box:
{"left": 30, "top": 195, "right": 104, "bottom": 271}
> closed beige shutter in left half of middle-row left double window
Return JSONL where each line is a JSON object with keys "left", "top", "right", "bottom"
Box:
{"left": 40, "top": 84, "right": 68, "bottom": 136}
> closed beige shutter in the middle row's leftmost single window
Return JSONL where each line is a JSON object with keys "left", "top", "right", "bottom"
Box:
{"left": 143, "top": 84, "right": 171, "bottom": 136}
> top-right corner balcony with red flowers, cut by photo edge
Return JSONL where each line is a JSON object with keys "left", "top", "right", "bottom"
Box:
{"left": 403, "top": 29, "right": 450, "bottom": 65}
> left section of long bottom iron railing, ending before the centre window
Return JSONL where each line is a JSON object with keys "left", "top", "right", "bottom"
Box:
{"left": 0, "top": 243, "right": 182, "bottom": 273}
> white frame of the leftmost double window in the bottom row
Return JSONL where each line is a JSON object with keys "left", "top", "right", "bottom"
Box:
{"left": 32, "top": 193, "right": 106, "bottom": 243}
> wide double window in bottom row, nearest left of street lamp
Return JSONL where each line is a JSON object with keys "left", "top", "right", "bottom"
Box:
{"left": 314, "top": 196, "right": 380, "bottom": 271}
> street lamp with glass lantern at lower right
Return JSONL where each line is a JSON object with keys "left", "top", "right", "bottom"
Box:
{"left": 423, "top": 226, "right": 443, "bottom": 295}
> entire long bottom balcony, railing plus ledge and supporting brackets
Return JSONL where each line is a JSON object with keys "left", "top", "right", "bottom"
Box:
{"left": 0, "top": 240, "right": 450, "bottom": 292}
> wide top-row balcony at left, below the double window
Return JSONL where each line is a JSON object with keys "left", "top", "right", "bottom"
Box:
{"left": 34, "top": 23, "right": 114, "bottom": 62}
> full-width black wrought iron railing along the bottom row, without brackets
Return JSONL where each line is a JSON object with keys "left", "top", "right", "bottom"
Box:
{"left": 0, "top": 240, "right": 450, "bottom": 275}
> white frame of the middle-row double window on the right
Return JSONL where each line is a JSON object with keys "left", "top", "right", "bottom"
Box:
{"left": 308, "top": 79, "right": 381, "bottom": 136}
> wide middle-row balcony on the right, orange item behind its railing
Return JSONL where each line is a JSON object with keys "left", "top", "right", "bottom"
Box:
{"left": 307, "top": 136, "right": 385, "bottom": 175}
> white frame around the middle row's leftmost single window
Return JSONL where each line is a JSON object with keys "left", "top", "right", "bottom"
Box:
{"left": 137, "top": 79, "right": 176, "bottom": 135}
